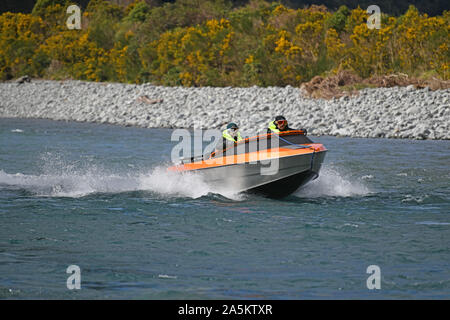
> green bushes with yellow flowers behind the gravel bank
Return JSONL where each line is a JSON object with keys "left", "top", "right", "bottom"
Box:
{"left": 0, "top": 0, "right": 450, "bottom": 86}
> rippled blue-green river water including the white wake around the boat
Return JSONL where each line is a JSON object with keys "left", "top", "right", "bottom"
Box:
{"left": 0, "top": 119, "right": 450, "bottom": 299}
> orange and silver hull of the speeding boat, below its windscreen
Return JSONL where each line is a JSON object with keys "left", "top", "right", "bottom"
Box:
{"left": 169, "top": 132, "right": 327, "bottom": 198}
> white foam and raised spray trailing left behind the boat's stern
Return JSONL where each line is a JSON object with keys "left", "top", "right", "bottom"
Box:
{"left": 0, "top": 152, "right": 225, "bottom": 198}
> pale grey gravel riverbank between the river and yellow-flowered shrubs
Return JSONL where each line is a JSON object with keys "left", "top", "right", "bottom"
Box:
{"left": 0, "top": 80, "right": 450, "bottom": 139}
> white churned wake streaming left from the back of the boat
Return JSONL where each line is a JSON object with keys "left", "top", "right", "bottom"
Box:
{"left": 0, "top": 162, "right": 246, "bottom": 200}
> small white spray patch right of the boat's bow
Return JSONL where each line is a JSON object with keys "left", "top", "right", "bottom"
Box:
{"left": 294, "top": 166, "right": 371, "bottom": 198}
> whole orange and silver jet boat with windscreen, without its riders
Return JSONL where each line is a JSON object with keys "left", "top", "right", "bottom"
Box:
{"left": 168, "top": 130, "right": 327, "bottom": 198}
